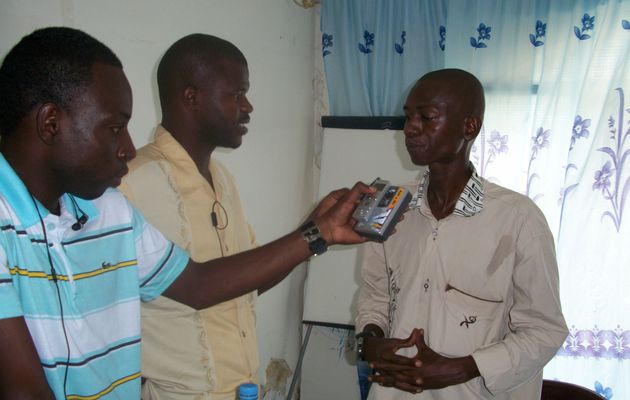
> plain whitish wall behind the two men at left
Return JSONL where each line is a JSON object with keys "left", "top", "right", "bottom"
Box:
{"left": 0, "top": 0, "right": 314, "bottom": 399}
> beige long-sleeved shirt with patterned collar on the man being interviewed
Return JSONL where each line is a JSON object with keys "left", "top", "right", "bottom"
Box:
{"left": 356, "top": 173, "right": 568, "bottom": 400}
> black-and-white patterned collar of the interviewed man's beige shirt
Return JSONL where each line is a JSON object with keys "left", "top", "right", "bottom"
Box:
{"left": 409, "top": 163, "right": 484, "bottom": 217}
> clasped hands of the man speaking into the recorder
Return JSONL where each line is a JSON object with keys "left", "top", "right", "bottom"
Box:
{"left": 364, "top": 328, "right": 479, "bottom": 393}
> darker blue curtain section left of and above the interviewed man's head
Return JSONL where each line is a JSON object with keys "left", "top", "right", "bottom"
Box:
{"left": 321, "top": 0, "right": 445, "bottom": 116}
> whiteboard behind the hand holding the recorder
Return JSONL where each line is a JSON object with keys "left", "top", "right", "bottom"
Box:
{"left": 303, "top": 128, "right": 424, "bottom": 325}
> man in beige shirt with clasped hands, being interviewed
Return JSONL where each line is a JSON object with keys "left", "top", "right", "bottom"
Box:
{"left": 356, "top": 69, "right": 568, "bottom": 400}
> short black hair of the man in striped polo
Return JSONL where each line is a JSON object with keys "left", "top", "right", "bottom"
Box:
{"left": 0, "top": 27, "right": 122, "bottom": 136}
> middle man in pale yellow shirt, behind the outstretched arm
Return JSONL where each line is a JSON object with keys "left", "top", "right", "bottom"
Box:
{"left": 119, "top": 34, "right": 346, "bottom": 400}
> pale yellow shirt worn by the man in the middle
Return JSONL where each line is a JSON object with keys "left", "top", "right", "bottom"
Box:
{"left": 119, "top": 126, "right": 259, "bottom": 400}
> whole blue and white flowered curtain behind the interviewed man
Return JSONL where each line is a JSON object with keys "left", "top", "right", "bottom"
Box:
{"left": 321, "top": 0, "right": 630, "bottom": 399}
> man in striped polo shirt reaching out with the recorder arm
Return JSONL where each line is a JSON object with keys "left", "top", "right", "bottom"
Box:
{"left": 0, "top": 28, "right": 371, "bottom": 400}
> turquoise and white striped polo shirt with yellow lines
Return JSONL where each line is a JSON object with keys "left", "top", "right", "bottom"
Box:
{"left": 0, "top": 155, "right": 188, "bottom": 400}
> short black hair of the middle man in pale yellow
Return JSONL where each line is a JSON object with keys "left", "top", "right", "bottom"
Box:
{"left": 157, "top": 33, "right": 247, "bottom": 109}
